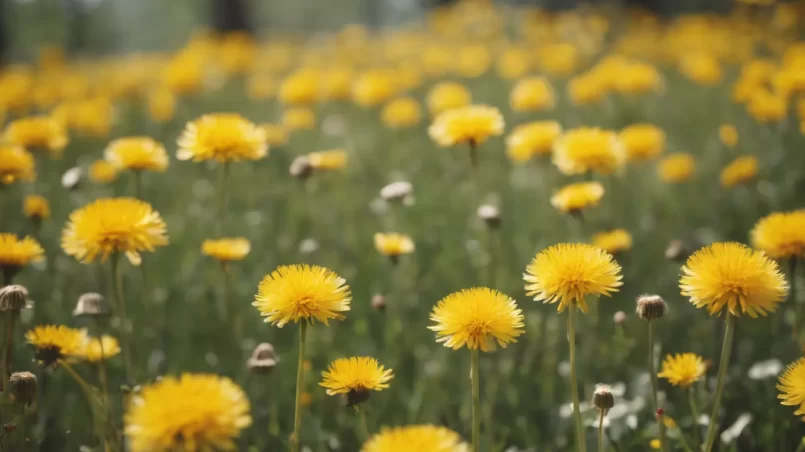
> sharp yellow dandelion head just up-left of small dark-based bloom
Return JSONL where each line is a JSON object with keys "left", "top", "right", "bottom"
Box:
{"left": 252, "top": 265, "right": 352, "bottom": 328}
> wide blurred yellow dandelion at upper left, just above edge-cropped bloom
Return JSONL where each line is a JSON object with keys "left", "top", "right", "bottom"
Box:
{"left": 4, "top": 116, "right": 68, "bottom": 157}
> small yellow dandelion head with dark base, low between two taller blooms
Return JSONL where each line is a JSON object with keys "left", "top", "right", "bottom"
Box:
{"left": 319, "top": 356, "right": 394, "bottom": 406}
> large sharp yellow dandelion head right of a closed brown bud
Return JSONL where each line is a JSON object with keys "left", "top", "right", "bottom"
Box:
{"left": 679, "top": 243, "right": 788, "bottom": 317}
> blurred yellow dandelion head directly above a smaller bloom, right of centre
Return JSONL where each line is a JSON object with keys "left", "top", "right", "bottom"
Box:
{"left": 553, "top": 127, "right": 626, "bottom": 174}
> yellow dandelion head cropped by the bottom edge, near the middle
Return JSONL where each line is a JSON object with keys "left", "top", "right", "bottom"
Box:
{"left": 361, "top": 425, "right": 468, "bottom": 452}
